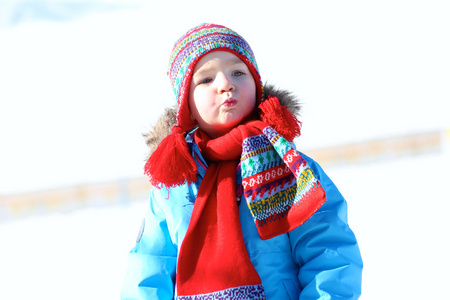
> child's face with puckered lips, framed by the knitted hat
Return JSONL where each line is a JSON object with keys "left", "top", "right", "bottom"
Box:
{"left": 189, "top": 51, "right": 256, "bottom": 138}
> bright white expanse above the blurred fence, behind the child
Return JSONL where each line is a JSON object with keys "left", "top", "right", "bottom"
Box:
{"left": 0, "top": 0, "right": 450, "bottom": 194}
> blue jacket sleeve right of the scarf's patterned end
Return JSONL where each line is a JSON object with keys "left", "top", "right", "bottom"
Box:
{"left": 289, "top": 154, "right": 363, "bottom": 300}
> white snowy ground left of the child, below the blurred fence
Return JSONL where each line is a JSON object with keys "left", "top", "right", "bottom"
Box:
{"left": 0, "top": 198, "right": 146, "bottom": 300}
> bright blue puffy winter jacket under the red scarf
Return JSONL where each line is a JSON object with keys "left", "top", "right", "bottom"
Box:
{"left": 121, "top": 131, "right": 362, "bottom": 300}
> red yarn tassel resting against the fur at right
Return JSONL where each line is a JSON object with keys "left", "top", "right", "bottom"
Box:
{"left": 259, "top": 97, "right": 301, "bottom": 142}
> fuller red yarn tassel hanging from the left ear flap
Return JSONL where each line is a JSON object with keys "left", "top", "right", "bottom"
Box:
{"left": 144, "top": 133, "right": 197, "bottom": 188}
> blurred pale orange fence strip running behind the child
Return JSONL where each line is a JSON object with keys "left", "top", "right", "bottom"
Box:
{"left": 0, "top": 130, "right": 450, "bottom": 222}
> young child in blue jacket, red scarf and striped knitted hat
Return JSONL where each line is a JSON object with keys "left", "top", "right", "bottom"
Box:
{"left": 121, "top": 24, "right": 362, "bottom": 300}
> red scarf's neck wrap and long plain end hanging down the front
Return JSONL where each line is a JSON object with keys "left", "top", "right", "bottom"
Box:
{"left": 177, "top": 125, "right": 265, "bottom": 299}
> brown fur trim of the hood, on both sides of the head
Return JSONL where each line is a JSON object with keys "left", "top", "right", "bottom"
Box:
{"left": 143, "top": 84, "right": 301, "bottom": 157}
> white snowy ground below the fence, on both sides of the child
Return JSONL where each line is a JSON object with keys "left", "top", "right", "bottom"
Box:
{"left": 0, "top": 149, "right": 450, "bottom": 300}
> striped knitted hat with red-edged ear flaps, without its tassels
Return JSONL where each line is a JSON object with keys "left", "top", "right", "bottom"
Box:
{"left": 167, "top": 24, "right": 264, "bottom": 131}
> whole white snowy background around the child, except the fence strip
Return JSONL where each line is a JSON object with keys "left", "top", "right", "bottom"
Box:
{"left": 0, "top": 0, "right": 450, "bottom": 300}
